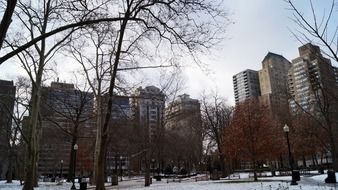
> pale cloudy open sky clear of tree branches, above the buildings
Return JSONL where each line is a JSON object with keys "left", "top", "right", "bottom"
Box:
{"left": 0, "top": 0, "right": 331, "bottom": 104}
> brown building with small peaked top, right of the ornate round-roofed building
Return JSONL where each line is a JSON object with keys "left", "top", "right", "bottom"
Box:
{"left": 165, "top": 94, "right": 202, "bottom": 170}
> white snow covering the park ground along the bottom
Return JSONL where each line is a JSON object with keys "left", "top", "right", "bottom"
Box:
{"left": 0, "top": 174, "right": 338, "bottom": 190}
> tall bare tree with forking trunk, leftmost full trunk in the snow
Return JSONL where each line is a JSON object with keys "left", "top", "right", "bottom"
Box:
{"left": 7, "top": 0, "right": 79, "bottom": 189}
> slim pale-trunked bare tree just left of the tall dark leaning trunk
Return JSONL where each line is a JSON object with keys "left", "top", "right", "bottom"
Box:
{"left": 70, "top": 21, "right": 121, "bottom": 184}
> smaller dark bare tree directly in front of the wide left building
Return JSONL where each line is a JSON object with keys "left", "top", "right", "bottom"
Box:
{"left": 40, "top": 83, "right": 94, "bottom": 181}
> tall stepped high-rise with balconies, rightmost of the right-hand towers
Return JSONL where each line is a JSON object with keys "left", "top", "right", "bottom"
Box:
{"left": 288, "top": 43, "right": 338, "bottom": 113}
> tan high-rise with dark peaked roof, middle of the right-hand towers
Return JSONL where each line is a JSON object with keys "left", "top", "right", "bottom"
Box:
{"left": 258, "top": 52, "right": 291, "bottom": 117}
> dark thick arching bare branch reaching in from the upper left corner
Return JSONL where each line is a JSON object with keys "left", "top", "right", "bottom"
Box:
{"left": 0, "top": 0, "right": 140, "bottom": 64}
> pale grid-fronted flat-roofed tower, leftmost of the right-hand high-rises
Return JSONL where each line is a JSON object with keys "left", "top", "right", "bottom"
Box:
{"left": 232, "top": 69, "right": 260, "bottom": 104}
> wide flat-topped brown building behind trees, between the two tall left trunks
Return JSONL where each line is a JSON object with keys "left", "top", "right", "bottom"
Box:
{"left": 38, "top": 82, "right": 96, "bottom": 176}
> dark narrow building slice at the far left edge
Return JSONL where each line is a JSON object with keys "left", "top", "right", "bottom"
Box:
{"left": 0, "top": 80, "right": 15, "bottom": 179}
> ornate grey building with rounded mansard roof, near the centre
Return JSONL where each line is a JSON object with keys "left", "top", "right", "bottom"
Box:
{"left": 132, "top": 86, "right": 165, "bottom": 142}
